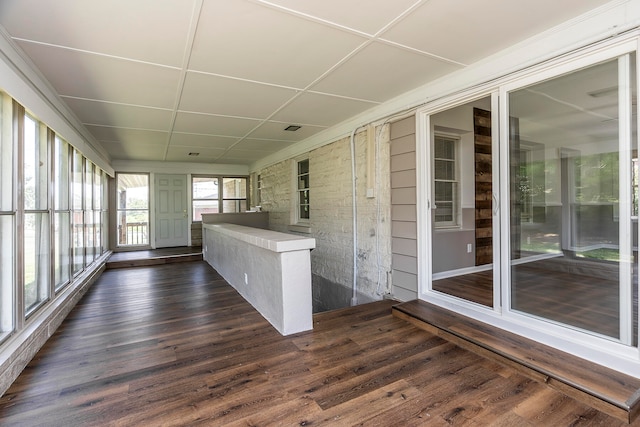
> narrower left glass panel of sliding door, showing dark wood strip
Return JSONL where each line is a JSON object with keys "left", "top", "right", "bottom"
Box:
{"left": 429, "top": 97, "right": 499, "bottom": 307}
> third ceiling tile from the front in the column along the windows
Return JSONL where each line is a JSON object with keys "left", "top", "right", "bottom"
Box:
{"left": 64, "top": 98, "right": 172, "bottom": 131}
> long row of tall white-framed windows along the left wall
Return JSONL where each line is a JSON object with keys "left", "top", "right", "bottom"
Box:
{"left": 0, "top": 91, "right": 108, "bottom": 342}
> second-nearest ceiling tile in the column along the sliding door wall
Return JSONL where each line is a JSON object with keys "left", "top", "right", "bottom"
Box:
{"left": 311, "top": 42, "right": 461, "bottom": 102}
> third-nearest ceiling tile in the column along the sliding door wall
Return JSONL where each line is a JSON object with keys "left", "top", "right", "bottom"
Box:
{"left": 273, "top": 93, "right": 376, "bottom": 126}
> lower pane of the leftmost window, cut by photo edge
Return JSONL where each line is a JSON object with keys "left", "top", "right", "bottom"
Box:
{"left": 0, "top": 215, "right": 15, "bottom": 338}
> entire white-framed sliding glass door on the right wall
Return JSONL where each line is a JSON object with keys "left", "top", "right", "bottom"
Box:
{"left": 417, "top": 43, "right": 639, "bottom": 357}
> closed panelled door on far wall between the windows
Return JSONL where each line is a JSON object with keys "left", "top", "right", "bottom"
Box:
{"left": 155, "top": 174, "right": 189, "bottom": 248}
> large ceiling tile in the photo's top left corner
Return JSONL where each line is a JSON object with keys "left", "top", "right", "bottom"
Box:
{"left": 0, "top": 0, "right": 194, "bottom": 66}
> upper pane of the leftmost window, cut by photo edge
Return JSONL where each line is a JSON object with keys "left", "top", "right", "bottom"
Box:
{"left": 0, "top": 93, "right": 14, "bottom": 211}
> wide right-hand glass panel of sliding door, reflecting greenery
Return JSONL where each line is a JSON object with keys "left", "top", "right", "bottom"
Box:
{"left": 508, "top": 55, "right": 638, "bottom": 344}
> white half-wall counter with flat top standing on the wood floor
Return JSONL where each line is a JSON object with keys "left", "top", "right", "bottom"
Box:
{"left": 202, "top": 224, "right": 316, "bottom": 335}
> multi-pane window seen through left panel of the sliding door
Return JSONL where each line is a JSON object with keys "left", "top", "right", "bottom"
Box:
{"left": 433, "top": 134, "right": 458, "bottom": 227}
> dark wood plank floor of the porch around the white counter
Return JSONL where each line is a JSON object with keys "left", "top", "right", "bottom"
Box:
{"left": 0, "top": 261, "right": 640, "bottom": 427}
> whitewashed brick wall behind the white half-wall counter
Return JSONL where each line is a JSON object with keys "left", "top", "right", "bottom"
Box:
{"left": 256, "top": 126, "right": 391, "bottom": 312}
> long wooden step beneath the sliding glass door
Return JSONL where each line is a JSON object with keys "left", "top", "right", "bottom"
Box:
{"left": 393, "top": 300, "right": 640, "bottom": 421}
